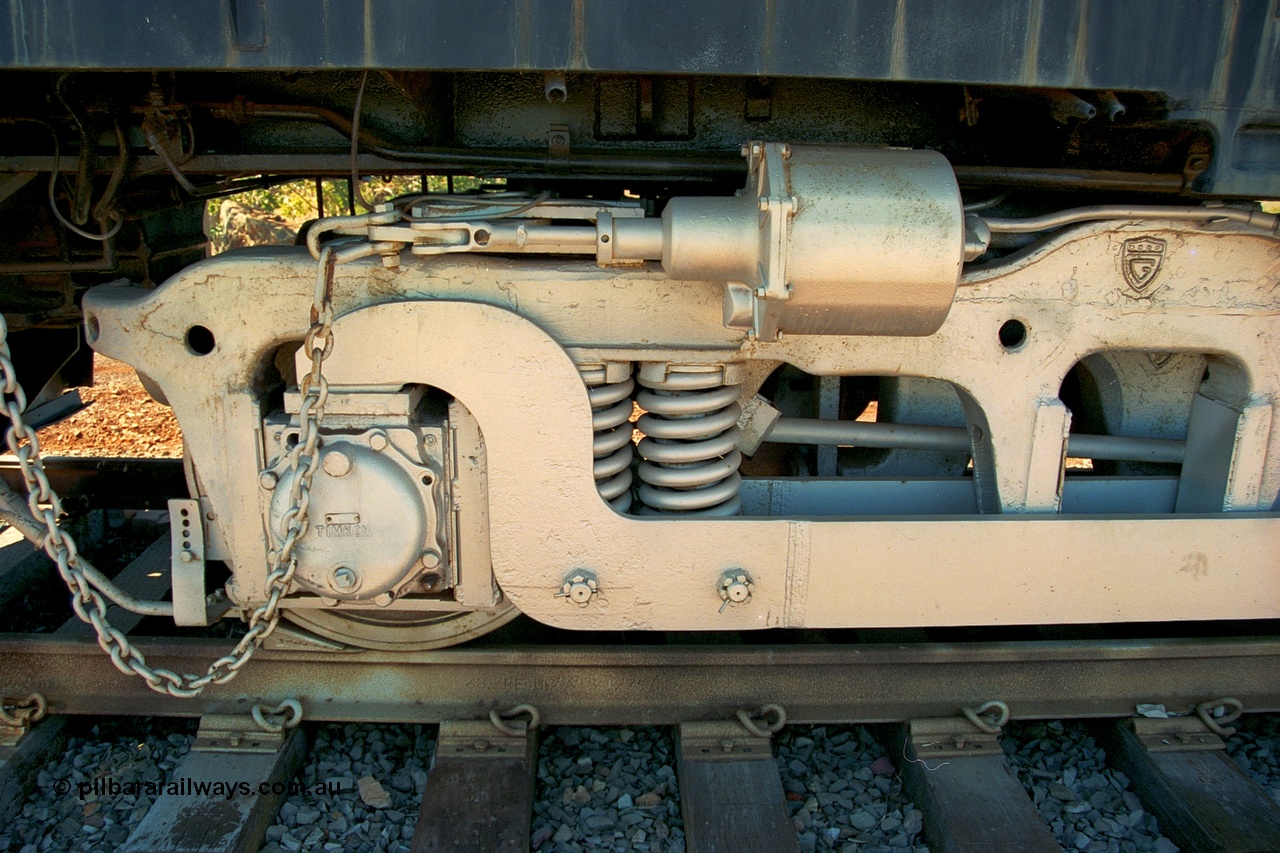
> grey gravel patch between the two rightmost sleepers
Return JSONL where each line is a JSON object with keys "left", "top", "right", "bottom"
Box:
{"left": 1001, "top": 721, "right": 1178, "bottom": 853}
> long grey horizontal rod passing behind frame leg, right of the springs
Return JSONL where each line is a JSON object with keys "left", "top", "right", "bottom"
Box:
{"left": 764, "top": 418, "right": 1187, "bottom": 465}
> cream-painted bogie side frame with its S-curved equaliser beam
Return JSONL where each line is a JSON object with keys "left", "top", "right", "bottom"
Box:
{"left": 84, "top": 216, "right": 1280, "bottom": 630}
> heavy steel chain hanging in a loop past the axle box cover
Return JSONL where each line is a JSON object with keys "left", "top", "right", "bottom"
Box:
{"left": 0, "top": 247, "right": 337, "bottom": 698}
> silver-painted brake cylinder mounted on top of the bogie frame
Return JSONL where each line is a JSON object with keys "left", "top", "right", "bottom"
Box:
{"left": 662, "top": 143, "right": 964, "bottom": 336}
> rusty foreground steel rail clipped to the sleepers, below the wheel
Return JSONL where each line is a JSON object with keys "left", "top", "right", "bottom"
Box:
{"left": 0, "top": 634, "right": 1280, "bottom": 725}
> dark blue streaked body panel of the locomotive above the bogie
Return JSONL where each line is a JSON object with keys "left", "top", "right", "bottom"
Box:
{"left": 0, "top": 0, "right": 1280, "bottom": 197}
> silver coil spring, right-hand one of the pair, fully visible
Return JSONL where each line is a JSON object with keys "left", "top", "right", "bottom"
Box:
{"left": 636, "top": 371, "right": 742, "bottom": 515}
